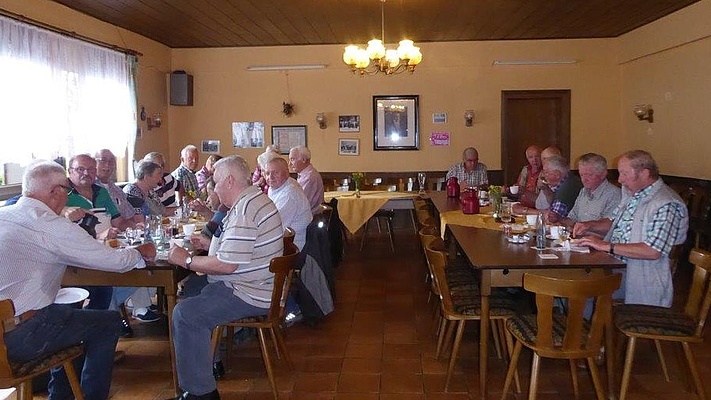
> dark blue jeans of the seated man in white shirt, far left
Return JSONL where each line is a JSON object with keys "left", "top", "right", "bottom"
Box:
{"left": 5, "top": 304, "right": 121, "bottom": 400}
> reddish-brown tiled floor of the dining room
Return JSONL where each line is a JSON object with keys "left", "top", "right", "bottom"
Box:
{"left": 35, "top": 230, "right": 711, "bottom": 400}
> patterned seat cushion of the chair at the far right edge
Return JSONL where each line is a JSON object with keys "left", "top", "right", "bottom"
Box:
{"left": 613, "top": 304, "right": 696, "bottom": 336}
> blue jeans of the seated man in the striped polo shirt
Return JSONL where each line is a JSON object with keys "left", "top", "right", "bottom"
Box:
{"left": 173, "top": 282, "right": 268, "bottom": 395}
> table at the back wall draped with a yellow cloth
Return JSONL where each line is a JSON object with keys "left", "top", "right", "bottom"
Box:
{"left": 324, "top": 190, "right": 419, "bottom": 234}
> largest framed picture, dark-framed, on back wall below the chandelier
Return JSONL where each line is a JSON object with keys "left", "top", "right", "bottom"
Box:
{"left": 373, "top": 95, "right": 420, "bottom": 150}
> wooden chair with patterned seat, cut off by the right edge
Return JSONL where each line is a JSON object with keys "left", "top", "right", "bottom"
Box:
{"left": 615, "top": 249, "right": 711, "bottom": 400}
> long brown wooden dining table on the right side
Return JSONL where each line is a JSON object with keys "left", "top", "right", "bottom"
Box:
{"left": 430, "top": 192, "right": 625, "bottom": 399}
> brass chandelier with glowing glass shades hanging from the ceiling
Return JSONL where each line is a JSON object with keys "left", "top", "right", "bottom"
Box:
{"left": 343, "top": 0, "right": 422, "bottom": 76}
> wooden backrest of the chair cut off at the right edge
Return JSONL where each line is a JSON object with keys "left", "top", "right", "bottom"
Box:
{"left": 684, "top": 248, "right": 711, "bottom": 337}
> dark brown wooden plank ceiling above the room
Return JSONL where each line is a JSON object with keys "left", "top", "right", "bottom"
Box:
{"left": 54, "top": 0, "right": 698, "bottom": 48}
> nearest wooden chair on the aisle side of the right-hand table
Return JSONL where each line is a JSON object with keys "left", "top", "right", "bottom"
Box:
{"left": 426, "top": 241, "right": 516, "bottom": 392}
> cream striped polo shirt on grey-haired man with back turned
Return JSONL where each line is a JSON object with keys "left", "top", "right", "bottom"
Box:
{"left": 208, "top": 186, "right": 284, "bottom": 308}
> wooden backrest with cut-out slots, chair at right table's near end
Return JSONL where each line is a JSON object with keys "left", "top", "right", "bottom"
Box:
{"left": 523, "top": 274, "right": 622, "bottom": 358}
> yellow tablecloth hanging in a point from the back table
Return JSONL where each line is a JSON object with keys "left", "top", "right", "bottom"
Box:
{"left": 324, "top": 190, "right": 417, "bottom": 233}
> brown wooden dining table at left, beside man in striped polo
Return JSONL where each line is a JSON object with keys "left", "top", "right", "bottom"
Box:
{"left": 62, "top": 260, "right": 188, "bottom": 395}
